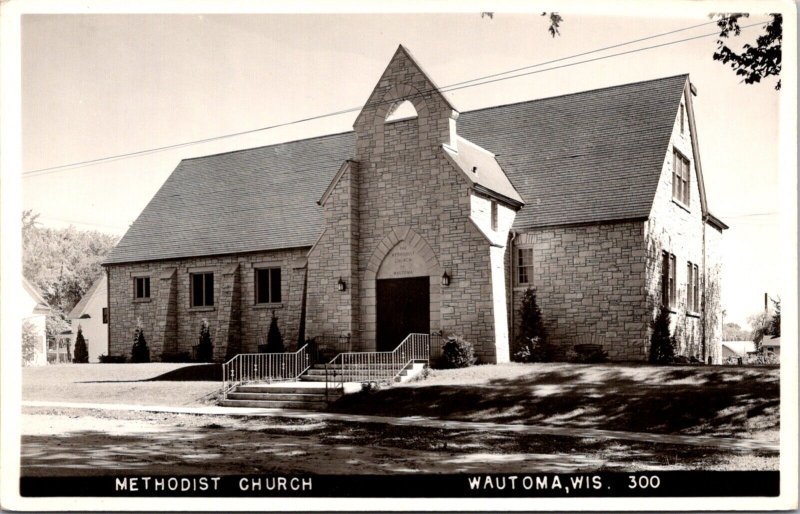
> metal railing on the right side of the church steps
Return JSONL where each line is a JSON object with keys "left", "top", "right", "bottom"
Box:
{"left": 325, "top": 334, "right": 431, "bottom": 390}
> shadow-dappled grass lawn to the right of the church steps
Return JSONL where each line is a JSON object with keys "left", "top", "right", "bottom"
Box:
{"left": 331, "top": 363, "right": 780, "bottom": 440}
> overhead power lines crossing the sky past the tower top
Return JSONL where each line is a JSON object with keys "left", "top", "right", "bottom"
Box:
{"left": 22, "top": 17, "right": 766, "bottom": 178}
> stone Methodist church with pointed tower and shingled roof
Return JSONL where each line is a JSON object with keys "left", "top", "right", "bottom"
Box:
{"left": 104, "top": 46, "right": 727, "bottom": 363}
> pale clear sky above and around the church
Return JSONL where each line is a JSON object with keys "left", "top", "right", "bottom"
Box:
{"left": 21, "top": 9, "right": 786, "bottom": 325}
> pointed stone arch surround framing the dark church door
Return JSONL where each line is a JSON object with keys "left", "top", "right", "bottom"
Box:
{"left": 361, "top": 227, "right": 442, "bottom": 350}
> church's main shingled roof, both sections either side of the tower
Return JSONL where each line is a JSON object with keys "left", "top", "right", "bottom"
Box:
{"left": 105, "top": 75, "right": 688, "bottom": 264}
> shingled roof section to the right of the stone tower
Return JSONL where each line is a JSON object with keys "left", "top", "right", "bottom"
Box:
{"left": 458, "top": 75, "right": 688, "bottom": 229}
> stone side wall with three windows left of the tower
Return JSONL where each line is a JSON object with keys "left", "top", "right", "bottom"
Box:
{"left": 107, "top": 248, "right": 308, "bottom": 360}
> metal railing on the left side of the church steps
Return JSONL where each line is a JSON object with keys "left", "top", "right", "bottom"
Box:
{"left": 222, "top": 345, "right": 311, "bottom": 398}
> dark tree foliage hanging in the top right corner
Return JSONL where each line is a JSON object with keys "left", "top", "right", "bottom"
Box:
{"left": 712, "top": 13, "right": 783, "bottom": 89}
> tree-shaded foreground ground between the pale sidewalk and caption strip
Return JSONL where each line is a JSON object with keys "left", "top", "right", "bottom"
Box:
{"left": 22, "top": 415, "right": 774, "bottom": 476}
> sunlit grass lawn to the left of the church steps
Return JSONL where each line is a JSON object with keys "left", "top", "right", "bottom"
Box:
{"left": 22, "top": 362, "right": 222, "bottom": 407}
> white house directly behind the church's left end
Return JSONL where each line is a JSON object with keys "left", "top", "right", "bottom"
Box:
{"left": 69, "top": 274, "right": 108, "bottom": 362}
